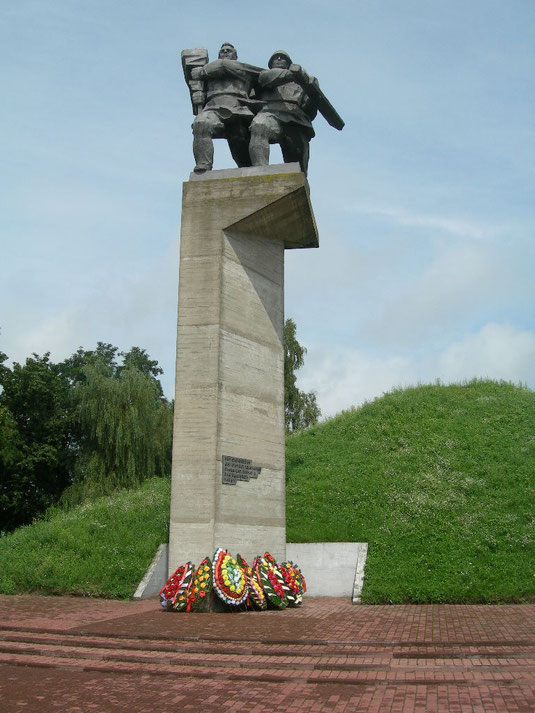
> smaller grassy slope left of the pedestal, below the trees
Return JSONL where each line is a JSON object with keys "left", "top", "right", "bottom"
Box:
{"left": 0, "top": 478, "right": 169, "bottom": 598}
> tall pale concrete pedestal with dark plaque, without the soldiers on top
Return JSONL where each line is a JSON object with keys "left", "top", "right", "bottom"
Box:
{"left": 169, "top": 164, "right": 318, "bottom": 572}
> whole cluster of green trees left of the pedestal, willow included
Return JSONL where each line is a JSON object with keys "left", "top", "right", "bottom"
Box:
{"left": 0, "top": 342, "right": 172, "bottom": 531}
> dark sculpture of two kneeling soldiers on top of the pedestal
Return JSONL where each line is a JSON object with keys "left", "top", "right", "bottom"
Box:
{"left": 182, "top": 42, "right": 344, "bottom": 175}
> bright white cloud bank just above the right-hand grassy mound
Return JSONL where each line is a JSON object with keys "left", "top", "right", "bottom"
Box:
{"left": 298, "top": 323, "right": 535, "bottom": 417}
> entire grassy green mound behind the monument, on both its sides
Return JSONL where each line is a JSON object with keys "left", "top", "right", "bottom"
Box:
{"left": 0, "top": 381, "right": 535, "bottom": 603}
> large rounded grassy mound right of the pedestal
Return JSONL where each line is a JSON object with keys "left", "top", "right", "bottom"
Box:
{"left": 286, "top": 381, "right": 535, "bottom": 603}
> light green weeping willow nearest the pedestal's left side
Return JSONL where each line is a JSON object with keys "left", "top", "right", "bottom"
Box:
{"left": 64, "top": 365, "right": 172, "bottom": 503}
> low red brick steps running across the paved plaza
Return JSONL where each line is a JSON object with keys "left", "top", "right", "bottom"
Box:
{"left": 0, "top": 632, "right": 535, "bottom": 685}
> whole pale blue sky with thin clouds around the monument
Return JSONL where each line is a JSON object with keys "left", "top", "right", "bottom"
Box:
{"left": 0, "top": 0, "right": 535, "bottom": 416}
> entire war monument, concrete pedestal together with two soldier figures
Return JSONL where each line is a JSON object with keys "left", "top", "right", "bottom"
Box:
{"left": 168, "top": 43, "right": 344, "bottom": 573}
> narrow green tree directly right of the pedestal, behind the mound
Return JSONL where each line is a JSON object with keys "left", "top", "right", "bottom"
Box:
{"left": 284, "top": 319, "right": 321, "bottom": 431}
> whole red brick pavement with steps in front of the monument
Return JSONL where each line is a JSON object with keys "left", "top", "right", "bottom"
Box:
{"left": 0, "top": 596, "right": 535, "bottom": 713}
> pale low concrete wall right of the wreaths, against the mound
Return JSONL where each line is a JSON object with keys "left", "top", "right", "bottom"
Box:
{"left": 286, "top": 542, "right": 368, "bottom": 604}
